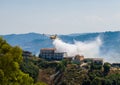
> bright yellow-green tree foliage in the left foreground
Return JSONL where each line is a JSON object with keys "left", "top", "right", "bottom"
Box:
{"left": 0, "top": 38, "right": 46, "bottom": 85}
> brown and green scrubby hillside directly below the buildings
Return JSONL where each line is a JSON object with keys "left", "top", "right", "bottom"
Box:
{"left": 19, "top": 54, "right": 120, "bottom": 85}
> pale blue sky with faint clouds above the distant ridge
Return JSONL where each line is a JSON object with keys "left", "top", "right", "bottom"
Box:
{"left": 0, "top": 0, "right": 120, "bottom": 34}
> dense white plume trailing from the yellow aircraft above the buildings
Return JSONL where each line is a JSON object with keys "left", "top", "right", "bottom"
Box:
{"left": 53, "top": 37, "right": 102, "bottom": 58}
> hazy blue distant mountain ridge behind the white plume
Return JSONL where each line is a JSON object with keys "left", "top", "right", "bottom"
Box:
{"left": 3, "top": 31, "right": 120, "bottom": 62}
